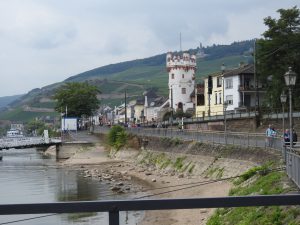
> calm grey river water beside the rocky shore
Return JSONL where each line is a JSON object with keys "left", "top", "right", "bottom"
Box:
{"left": 0, "top": 148, "right": 143, "bottom": 225}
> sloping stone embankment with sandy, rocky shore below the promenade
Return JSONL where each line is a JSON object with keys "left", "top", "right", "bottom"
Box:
{"left": 44, "top": 136, "right": 280, "bottom": 225}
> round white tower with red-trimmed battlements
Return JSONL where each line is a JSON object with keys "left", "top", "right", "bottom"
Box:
{"left": 167, "top": 53, "right": 197, "bottom": 112}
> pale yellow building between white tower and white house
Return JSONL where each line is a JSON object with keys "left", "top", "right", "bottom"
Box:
{"left": 196, "top": 72, "right": 224, "bottom": 117}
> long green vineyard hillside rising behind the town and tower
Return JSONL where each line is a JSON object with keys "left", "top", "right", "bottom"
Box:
{"left": 0, "top": 41, "right": 253, "bottom": 121}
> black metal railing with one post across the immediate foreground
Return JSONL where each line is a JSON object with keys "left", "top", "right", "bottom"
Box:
{"left": 0, "top": 194, "right": 300, "bottom": 225}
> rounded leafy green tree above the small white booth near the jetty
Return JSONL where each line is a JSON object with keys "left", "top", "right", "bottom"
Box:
{"left": 53, "top": 82, "right": 100, "bottom": 117}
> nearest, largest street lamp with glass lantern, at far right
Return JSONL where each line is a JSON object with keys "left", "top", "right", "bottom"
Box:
{"left": 284, "top": 67, "right": 297, "bottom": 151}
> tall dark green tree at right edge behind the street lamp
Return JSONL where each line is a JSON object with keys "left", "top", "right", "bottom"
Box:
{"left": 257, "top": 6, "right": 300, "bottom": 107}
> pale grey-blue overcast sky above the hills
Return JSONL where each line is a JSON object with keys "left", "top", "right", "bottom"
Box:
{"left": 0, "top": 0, "right": 299, "bottom": 96}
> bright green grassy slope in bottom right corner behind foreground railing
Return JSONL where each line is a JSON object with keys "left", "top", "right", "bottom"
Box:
{"left": 207, "top": 164, "right": 300, "bottom": 225}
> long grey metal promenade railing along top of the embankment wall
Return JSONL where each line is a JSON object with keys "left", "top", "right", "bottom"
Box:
{"left": 96, "top": 127, "right": 300, "bottom": 188}
